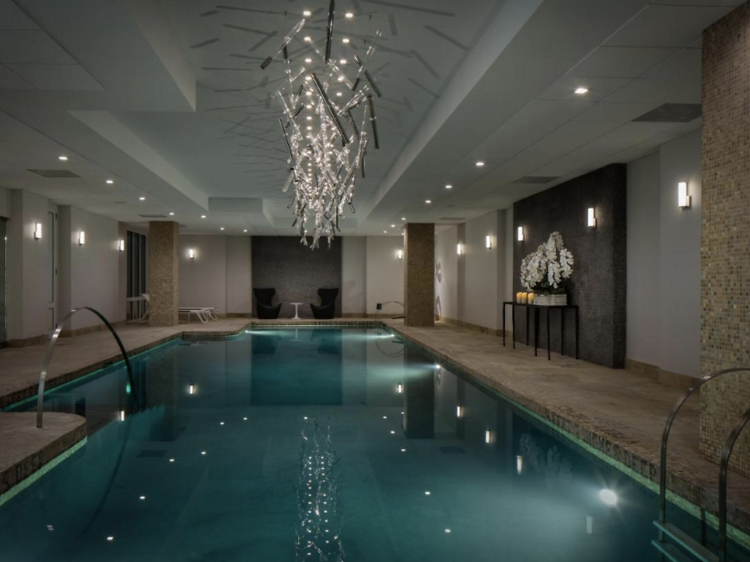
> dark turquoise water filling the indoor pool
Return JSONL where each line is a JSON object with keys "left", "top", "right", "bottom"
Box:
{"left": 0, "top": 329, "right": 747, "bottom": 562}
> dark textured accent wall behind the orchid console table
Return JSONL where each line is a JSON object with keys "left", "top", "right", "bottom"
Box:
{"left": 513, "top": 164, "right": 627, "bottom": 368}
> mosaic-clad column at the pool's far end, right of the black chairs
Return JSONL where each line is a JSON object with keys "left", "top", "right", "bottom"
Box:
{"left": 404, "top": 223, "right": 435, "bottom": 327}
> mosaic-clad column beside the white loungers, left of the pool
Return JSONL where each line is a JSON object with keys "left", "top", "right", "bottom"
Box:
{"left": 148, "top": 221, "right": 180, "bottom": 326}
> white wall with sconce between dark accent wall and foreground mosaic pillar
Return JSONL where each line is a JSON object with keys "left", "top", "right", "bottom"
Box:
{"left": 627, "top": 130, "right": 701, "bottom": 376}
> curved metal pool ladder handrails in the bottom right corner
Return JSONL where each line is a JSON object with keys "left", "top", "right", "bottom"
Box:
{"left": 654, "top": 367, "right": 750, "bottom": 562}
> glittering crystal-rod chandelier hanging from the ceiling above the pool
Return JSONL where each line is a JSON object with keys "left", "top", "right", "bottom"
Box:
{"left": 261, "top": 0, "right": 381, "bottom": 248}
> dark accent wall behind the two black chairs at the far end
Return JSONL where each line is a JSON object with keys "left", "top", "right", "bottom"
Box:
{"left": 252, "top": 236, "right": 341, "bottom": 318}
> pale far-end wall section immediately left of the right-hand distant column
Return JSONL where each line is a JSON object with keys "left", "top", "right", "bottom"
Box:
{"left": 366, "top": 236, "right": 404, "bottom": 315}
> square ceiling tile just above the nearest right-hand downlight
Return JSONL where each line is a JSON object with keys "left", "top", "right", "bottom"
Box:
{"left": 568, "top": 46, "right": 680, "bottom": 78}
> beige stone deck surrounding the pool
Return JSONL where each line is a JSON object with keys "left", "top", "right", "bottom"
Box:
{"left": 0, "top": 318, "right": 750, "bottom": 533}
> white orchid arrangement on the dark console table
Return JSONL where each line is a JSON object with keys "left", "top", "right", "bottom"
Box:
{"left": 521, "top": 232, "right": 573, "bottom": 293}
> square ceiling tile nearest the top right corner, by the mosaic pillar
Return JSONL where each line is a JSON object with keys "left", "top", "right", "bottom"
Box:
{"left": 605, "top": 5, "right": 732, "bottom": 47}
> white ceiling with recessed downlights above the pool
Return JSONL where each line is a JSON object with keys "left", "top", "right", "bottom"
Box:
{"left": 0, "top": 0, "right": 742, "bottom": 234}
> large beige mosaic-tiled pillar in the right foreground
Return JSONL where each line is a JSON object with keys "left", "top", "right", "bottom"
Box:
{"left": 704, "top": 4, "right": 750, "bottom": 476}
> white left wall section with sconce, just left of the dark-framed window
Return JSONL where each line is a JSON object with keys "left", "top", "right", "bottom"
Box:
{"left": 58, "top": 205, "right": 126, "bottom": 330}
